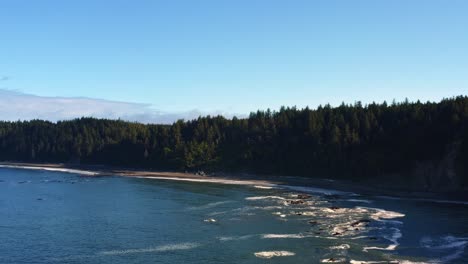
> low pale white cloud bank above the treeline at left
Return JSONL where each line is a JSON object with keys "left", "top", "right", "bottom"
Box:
{"left": 0, "top": 89, "right": 236, "bottom": 124}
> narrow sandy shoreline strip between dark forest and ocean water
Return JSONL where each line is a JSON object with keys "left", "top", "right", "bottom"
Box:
{"left": 0, "top": 162, "right": 468, "bottom": 205}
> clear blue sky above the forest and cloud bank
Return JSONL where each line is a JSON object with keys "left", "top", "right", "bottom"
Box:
{"left": 0, "top": 0, "right": 468, "bottom": 119}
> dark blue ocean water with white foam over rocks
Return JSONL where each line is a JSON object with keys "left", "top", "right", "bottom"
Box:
{"left": 0, "top": 168, "right": 468, "bottom": 263}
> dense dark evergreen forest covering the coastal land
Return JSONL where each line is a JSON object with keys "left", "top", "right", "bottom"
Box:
{"left": 0, "top": 96, "right": 468, "bottom": 186}
